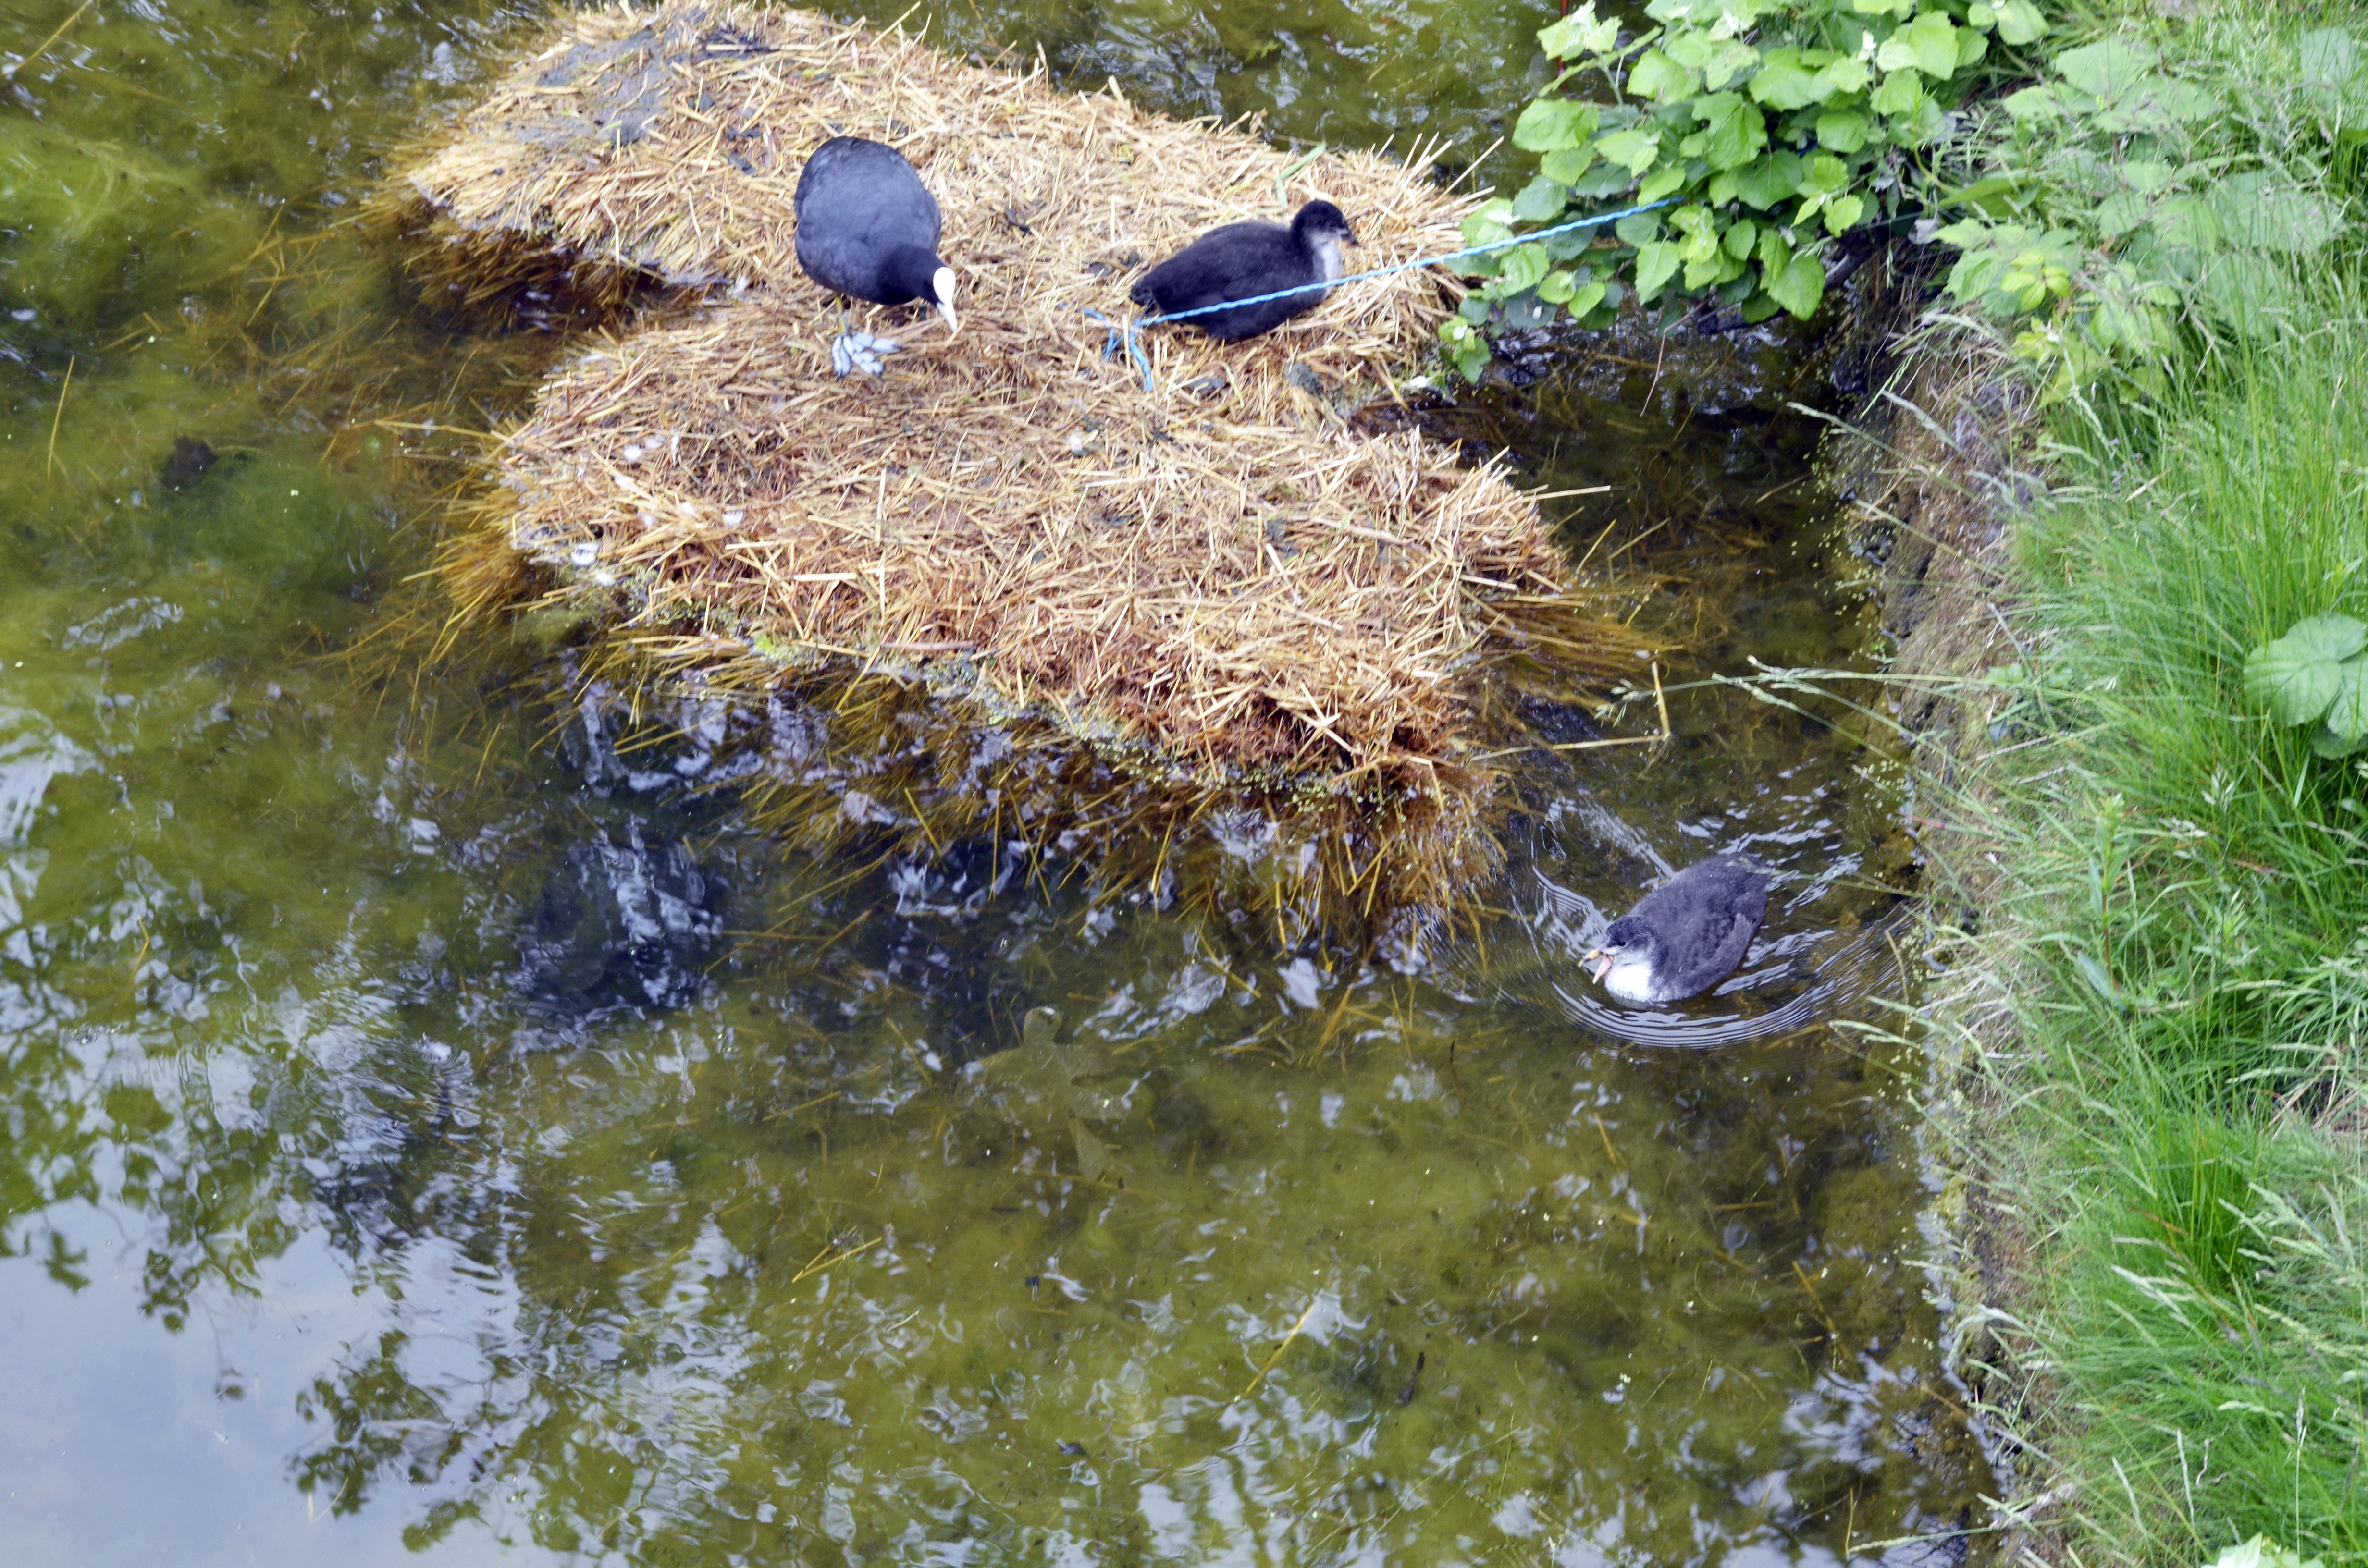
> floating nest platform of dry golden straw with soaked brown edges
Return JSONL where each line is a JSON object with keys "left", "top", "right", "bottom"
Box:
{"left": 381, "top": 2, "right": 1639, "bottom": 933}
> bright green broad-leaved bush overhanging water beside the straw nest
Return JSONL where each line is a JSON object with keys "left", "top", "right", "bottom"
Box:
{"left": 1440, "top": 0, "right": 2046, "bottom": 374}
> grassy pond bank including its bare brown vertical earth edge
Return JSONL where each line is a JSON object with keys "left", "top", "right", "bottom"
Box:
{"left": 1835, "top": 231, "right": 2368, "bottom": 1566}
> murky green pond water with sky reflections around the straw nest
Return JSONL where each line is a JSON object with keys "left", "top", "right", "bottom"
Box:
{"left": 0, "top": 0, "right": 1996, "bottom": 1568}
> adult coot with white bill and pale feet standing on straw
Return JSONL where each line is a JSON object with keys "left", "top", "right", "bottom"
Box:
{"left": 796, "top": 135, "right": 962, "bottom": 377}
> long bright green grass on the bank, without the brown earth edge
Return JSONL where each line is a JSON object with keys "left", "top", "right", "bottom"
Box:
{"left": 1932, "top": 284, "right": 2368, "bottom": 1563}
